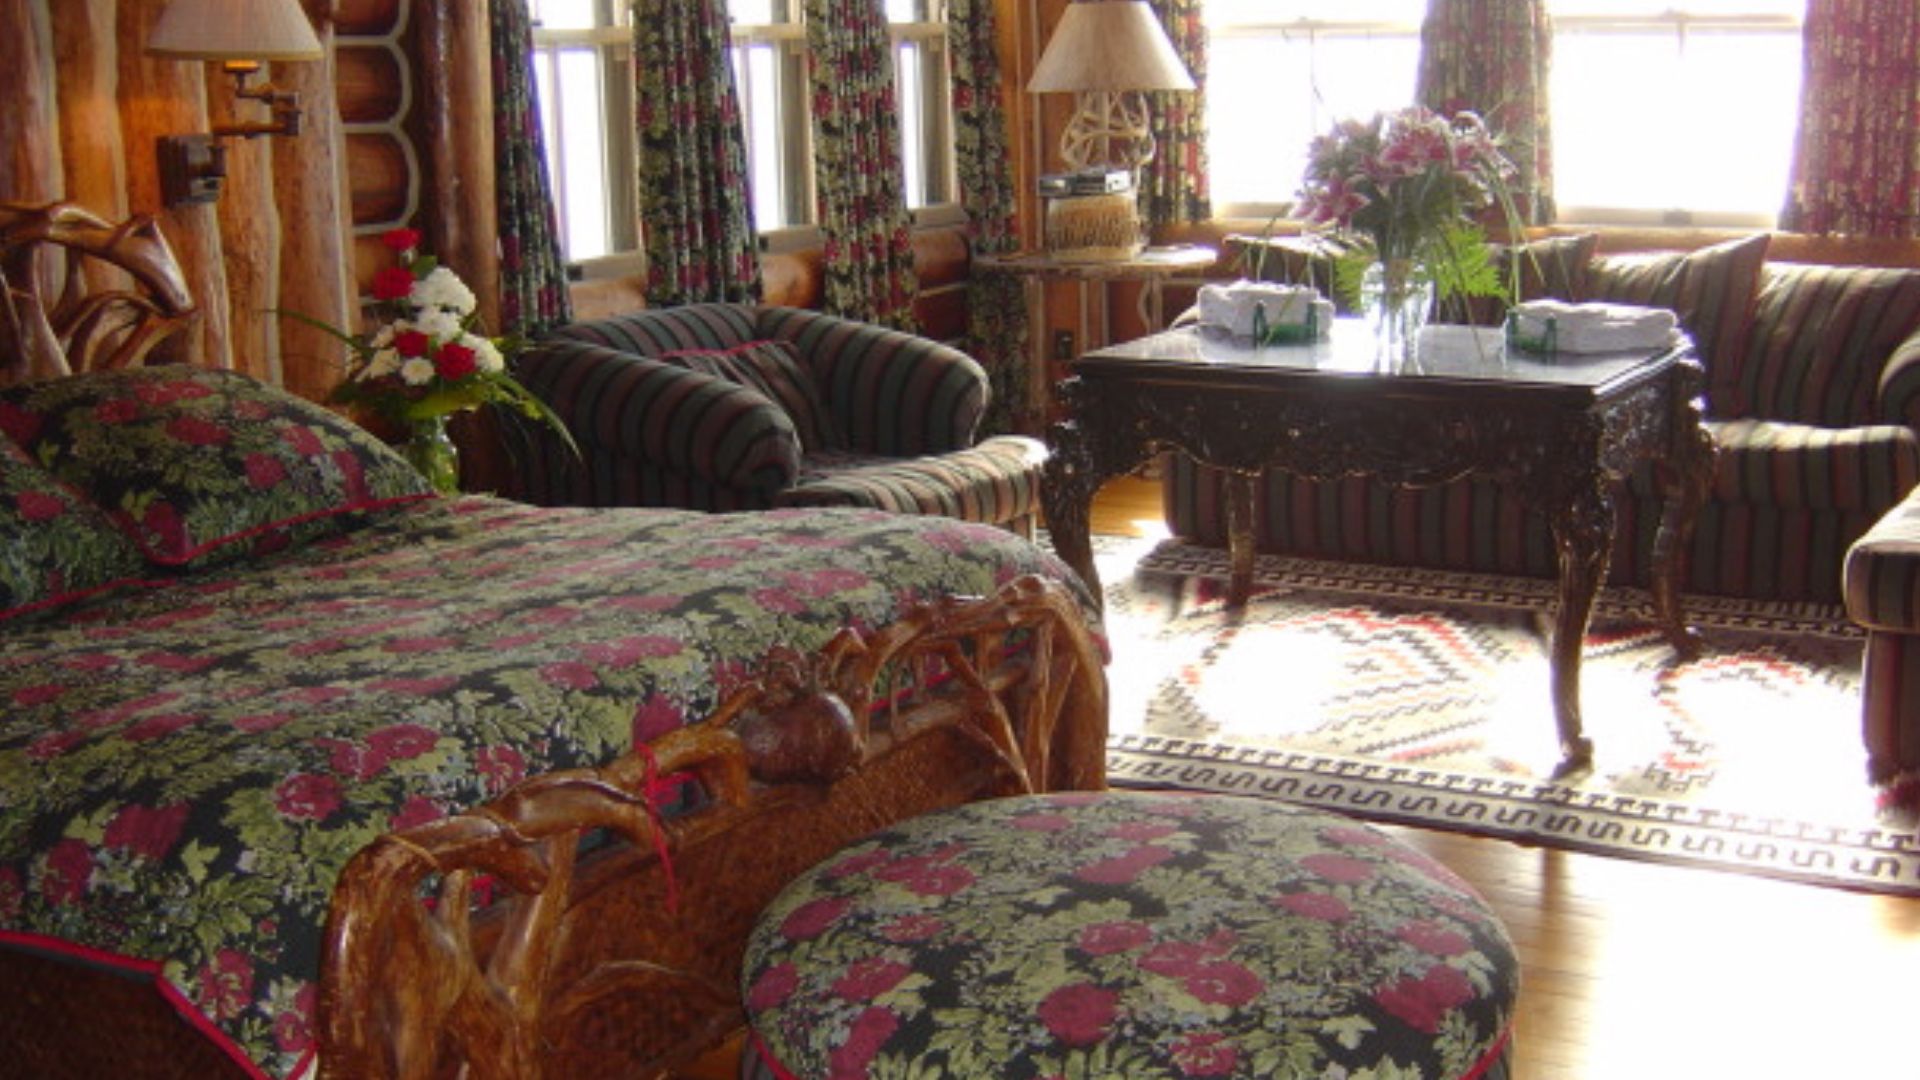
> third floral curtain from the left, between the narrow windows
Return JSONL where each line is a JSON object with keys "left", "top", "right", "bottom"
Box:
{"left": 806, "top": 0, "right": 920, "bottom": 331}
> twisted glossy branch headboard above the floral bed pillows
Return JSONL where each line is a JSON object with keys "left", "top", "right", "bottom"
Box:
{"left": 0, "top": 202, "right": 200, "bottom": 384}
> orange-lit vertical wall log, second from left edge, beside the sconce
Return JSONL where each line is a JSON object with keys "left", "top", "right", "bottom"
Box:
{"left": 52, "top": 0, "right": 127, "bottom": 226}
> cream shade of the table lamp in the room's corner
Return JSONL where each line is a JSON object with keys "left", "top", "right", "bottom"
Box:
{"left": 1027, "top": 0, "right": 1194, "bottom": 94}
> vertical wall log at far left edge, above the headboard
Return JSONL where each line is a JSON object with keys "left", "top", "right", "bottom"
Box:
{"left": 0, "top": 0, "right": 65, "bottom": 202}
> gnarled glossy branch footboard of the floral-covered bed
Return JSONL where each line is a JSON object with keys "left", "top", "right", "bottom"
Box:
{"left": 319, "top": 577, "right": 1106, "bottom": 1078}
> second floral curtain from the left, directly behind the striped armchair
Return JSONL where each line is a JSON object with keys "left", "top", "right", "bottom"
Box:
{"left": 634, "top": 0, "right": 760, "bottom": 307}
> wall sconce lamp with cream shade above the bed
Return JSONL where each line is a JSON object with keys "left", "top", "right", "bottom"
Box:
{"left": 146, "top": 0, "right": 324, "bottom": 206}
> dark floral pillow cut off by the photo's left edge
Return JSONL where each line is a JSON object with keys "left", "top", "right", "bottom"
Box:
{"left": 0, "top": 428, "right": 146, "bottom": 619}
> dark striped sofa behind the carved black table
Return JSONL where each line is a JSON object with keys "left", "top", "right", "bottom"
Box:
{"left": 1164, "top": 234, "right": 1920, "bottom": 603}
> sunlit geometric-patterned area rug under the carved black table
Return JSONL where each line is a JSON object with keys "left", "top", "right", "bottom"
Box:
{"left": 1098, "top": 538, "right": 1920, "bottom": 896}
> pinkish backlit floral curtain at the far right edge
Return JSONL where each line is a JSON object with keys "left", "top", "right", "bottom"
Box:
{"left": 1780, "top": 0, "right": 1920, "bottom": 236}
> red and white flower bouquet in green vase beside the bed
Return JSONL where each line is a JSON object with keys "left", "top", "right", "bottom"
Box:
{"left": 290, "top": 229, "right": 572, "bottom": 494}
